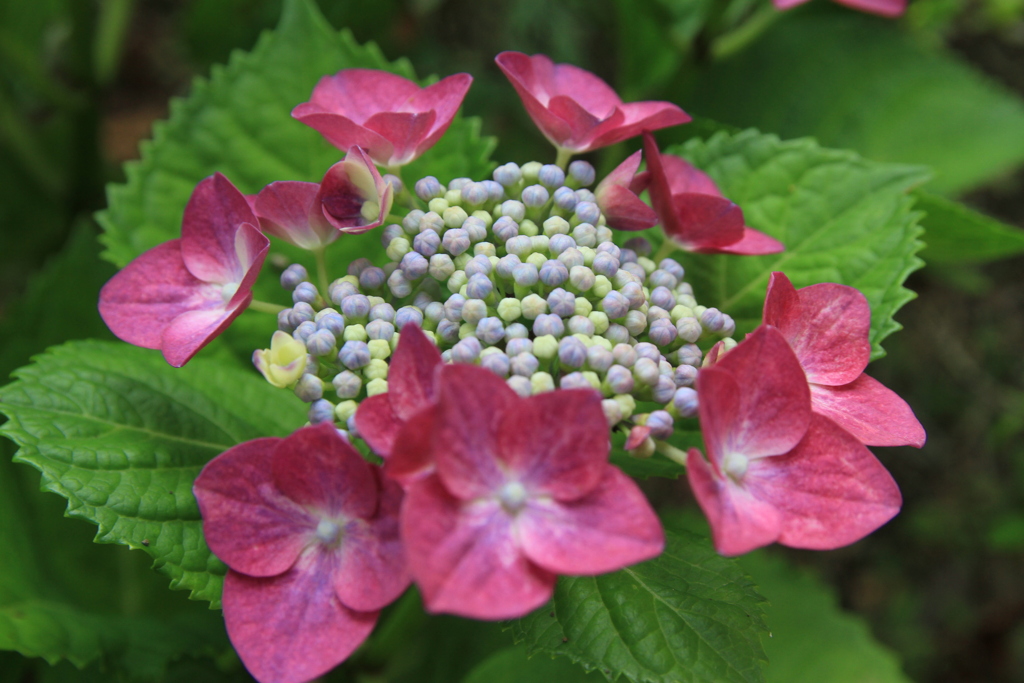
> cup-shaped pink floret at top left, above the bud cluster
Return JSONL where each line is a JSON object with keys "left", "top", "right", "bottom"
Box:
{"left": 292, "top": 69, "right": 473, "bottom": 167}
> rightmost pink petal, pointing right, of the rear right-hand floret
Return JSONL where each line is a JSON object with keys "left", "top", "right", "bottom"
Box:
{"left": 811, "top": 375, "right": 925, "bottom": 449}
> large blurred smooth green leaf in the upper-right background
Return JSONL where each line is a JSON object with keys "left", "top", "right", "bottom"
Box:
{"left": 677, "top": 8, "right": 1024, "bottom": 193}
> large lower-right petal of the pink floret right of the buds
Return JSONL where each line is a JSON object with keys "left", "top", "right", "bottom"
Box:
{"left": 742, "top": 416, "right": 902, "bottom": 550}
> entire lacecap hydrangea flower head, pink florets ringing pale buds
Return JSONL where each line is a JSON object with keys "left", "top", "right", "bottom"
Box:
{"left": 100, "top": 52, "right": 924, "bottom": 683}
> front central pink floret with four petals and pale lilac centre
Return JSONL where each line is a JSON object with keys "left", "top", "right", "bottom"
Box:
{"left": 396, "top": 365, "right": 664, "bottom": 620}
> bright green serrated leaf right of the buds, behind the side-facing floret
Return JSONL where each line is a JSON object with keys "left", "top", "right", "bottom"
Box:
{"left": 670, "top": 130, "right": 928, "bottom": 358}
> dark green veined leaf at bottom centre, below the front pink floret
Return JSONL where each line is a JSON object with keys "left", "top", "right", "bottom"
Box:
{"left": 512, "top": 529, "right": 767, "bottom": 683}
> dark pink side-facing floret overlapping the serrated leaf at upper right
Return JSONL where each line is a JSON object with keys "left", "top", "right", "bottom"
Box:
{"left": 637, "top": 132, "right": 785, "bottom": 255}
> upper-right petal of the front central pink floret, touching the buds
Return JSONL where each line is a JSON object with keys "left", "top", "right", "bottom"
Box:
{"left": 495, "top": 389, "right": 610, "bottom": 501}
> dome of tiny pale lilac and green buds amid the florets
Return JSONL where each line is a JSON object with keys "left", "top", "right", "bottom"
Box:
{"left": 258, "top": 161, "right": 735, "bottom": 454}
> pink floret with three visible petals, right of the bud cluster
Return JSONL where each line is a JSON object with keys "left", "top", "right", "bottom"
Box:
{"left": 686, "top": 326, "right": 901, "bottom": 555}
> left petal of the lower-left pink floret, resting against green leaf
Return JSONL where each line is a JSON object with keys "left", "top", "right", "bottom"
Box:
{"left": 193, "top": 438, "right": 316, "bottom": 577}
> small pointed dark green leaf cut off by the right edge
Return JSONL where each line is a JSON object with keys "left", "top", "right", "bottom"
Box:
{"left": 915, "top": 190, "right": 1024, "bottom": 263}
